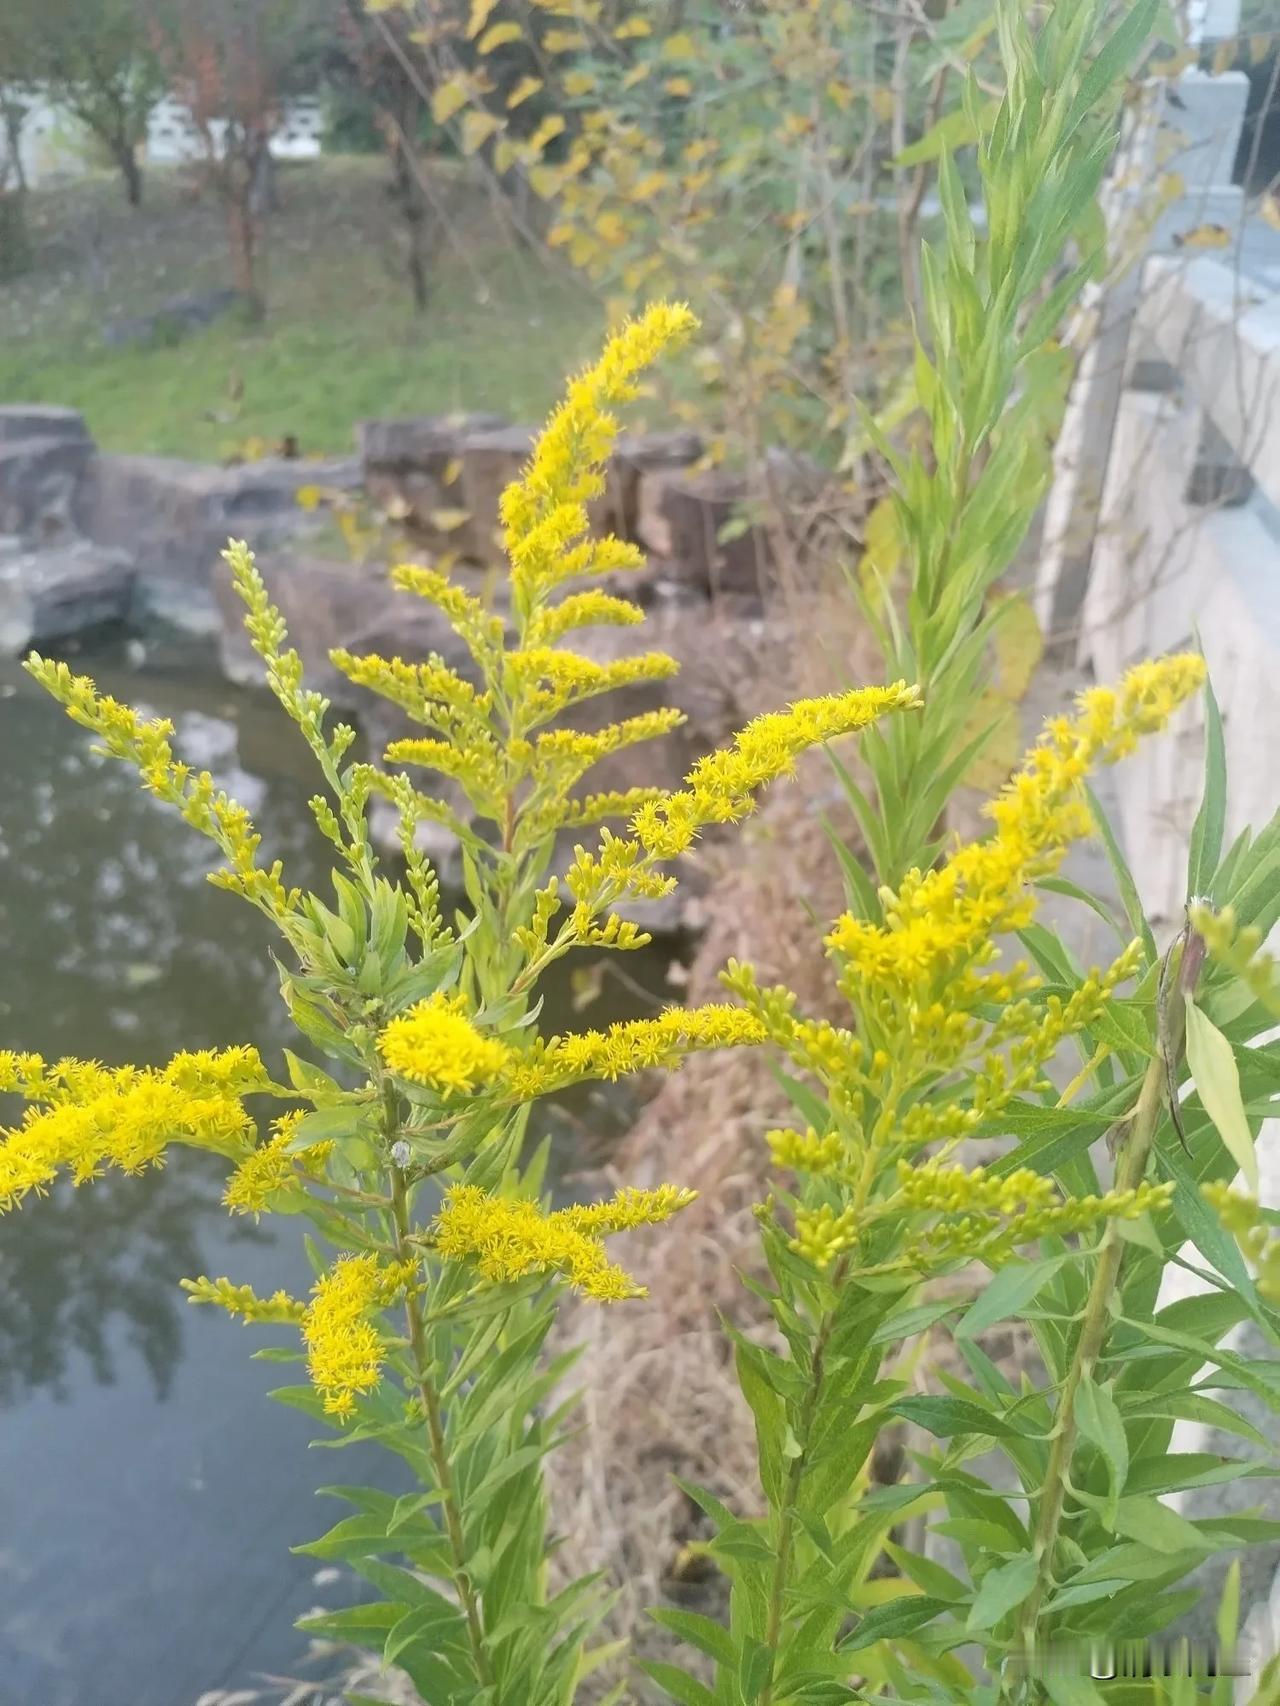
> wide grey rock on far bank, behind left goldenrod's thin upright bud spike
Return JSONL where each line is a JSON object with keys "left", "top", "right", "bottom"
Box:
{"left": 85, "top": 456, "right": 360, "bottom": 635}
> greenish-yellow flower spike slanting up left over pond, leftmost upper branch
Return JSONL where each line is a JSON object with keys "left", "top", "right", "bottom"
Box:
{"left": 22, "top": 652, "right": 297, "bottom": 918}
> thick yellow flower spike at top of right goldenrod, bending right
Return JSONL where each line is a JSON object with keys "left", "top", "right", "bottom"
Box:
{"left": 828, "top": 653, "right": 1205, "bottom": 1001}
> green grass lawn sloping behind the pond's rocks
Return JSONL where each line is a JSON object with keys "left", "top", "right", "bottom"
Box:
{"left": 0, "top": 157, "right": 602, "bottom": 461}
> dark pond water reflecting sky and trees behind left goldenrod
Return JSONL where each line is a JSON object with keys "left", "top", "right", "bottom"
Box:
{"left": 0, "top": 641, "right": 671, "bottom": 1706}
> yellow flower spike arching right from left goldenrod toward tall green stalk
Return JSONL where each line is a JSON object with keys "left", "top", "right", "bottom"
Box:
{"left": 631, "top": 681, "right": 920, "bottom": 858}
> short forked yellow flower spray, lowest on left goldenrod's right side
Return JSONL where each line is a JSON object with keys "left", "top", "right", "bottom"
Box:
{"left": 432, "top": 1184, "right": 695, "bottom": 1303}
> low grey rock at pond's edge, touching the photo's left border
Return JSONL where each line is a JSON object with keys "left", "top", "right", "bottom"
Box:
{"left": 0, "top": 539, "right": 135, "bottom": 657}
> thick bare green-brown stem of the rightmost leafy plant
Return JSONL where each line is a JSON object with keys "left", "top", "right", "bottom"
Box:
{"left": 1014, "top": 1054, "right": 1166, "bottom": 1685}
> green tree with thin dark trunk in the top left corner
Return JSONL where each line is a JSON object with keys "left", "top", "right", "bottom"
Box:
{"left": 0, "top": 0, "right": 164, "bottom": 206}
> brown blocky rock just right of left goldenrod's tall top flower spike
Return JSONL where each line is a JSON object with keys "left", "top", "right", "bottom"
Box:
{"left": 637, "top": 469, "right": 770, "bottom": 599}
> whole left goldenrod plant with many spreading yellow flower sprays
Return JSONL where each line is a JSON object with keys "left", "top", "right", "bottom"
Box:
{"left": 0, "top": 304, "right": 920, "bottom": 1706}
